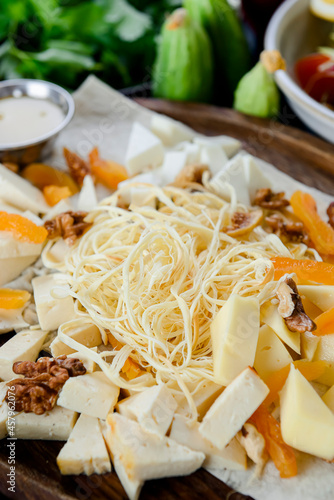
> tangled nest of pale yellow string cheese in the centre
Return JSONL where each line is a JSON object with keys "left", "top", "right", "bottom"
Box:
{"left": 53, "top": 181, "right": 314, "bottom": 414}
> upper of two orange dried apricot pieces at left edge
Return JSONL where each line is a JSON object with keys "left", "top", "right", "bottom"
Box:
{"left": 0, "top": 212, "right": 48, "bottom": 244}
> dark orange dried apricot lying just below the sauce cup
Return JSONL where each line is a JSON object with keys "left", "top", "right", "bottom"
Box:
{"left": 22, "top": 163, "right": 79, "bottom": 194}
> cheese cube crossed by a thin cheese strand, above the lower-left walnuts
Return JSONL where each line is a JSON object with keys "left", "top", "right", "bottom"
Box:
{"left": 50, "top": 323, "right": 102, "bottom": 358}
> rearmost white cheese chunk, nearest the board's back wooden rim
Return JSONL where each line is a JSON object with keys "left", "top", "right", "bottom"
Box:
{"left": 150, "top": 114, "right": 195, "bottom": 147}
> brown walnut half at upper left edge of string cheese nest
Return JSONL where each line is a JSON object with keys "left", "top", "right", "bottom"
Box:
{"left": 44, "top": 211, "right": 92, "bottom": 245}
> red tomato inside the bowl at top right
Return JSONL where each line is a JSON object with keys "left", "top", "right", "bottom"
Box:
{"left": 295, "top": 54, "right": 334, "bottom": 106}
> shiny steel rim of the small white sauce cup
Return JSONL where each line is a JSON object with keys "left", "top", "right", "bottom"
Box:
{"left": 0, "top": 78, "right": 75, "bottom": 151}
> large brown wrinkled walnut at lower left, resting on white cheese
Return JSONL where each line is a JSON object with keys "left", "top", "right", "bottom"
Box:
{"left": 6, "top": 356, "right": 86, "bottom": 415}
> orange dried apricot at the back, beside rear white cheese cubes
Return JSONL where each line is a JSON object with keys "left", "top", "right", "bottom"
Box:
{"left": 89, "top": 148, "right": 129, "bottom": 189}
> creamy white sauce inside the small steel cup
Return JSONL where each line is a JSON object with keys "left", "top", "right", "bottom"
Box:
{"left": 0, "top": 97, "right": 64, "bottom": 146}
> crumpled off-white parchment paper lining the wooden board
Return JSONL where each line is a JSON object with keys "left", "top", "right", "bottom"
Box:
{"left": 50, "top": 76, "right": 334, "bottom": 500}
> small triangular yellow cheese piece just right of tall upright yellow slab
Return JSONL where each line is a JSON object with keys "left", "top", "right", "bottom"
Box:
{"left": 254, "top": 325, "right": 293, "bottom": 380}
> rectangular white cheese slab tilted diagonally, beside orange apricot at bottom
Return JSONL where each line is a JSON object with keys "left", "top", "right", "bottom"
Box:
{"left": 199, "top": 367, "right": 269, "bottom": 449}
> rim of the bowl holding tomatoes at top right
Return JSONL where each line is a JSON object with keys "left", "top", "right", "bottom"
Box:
{"left": 264, "top": 0, "right": 334, "bottom": 126}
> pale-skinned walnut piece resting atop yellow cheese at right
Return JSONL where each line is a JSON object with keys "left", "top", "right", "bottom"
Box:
{"left": 276, "top": 278, "right": 317, "bottom": 333}
